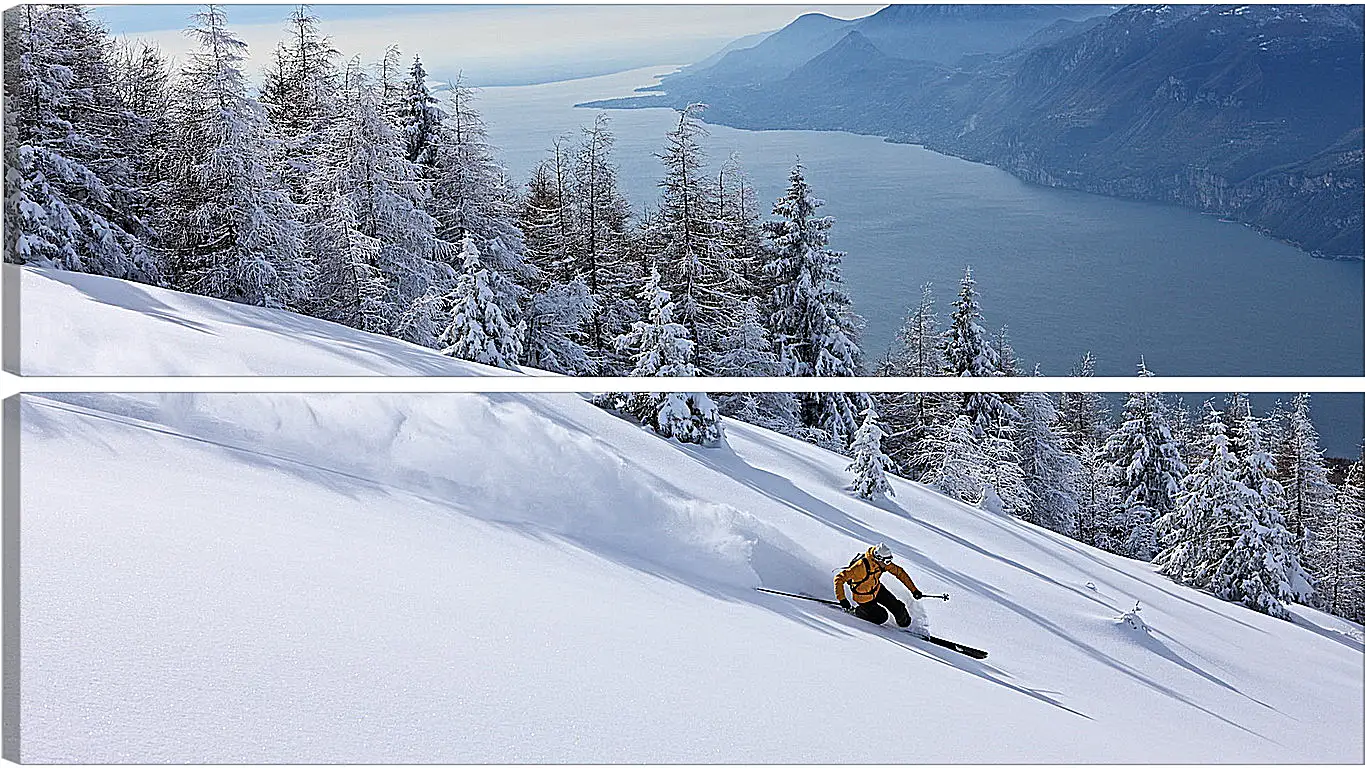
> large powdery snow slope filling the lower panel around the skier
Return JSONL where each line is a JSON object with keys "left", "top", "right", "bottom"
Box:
{"left": 18, "top": 390, "right": 1365, "bottom": 763}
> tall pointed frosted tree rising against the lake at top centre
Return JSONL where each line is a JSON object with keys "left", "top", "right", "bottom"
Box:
{"left": 647, "top": 104, "right": 743, "bottom": 372}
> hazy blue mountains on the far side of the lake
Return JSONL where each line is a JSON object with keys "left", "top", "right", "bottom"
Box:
{"left": 595, "top": 5, "right": 1365, "bottom": 258}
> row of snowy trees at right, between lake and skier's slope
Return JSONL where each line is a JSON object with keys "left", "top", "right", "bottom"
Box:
{"left": 849, "top": 269, "right": 1365, "bottom": 621}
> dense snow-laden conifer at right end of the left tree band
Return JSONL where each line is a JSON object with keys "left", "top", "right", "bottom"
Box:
{"left": 764, "top": 162, "right": 867, "bottom": 445}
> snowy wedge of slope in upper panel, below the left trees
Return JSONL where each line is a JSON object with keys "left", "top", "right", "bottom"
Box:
{"left": 4, "top": 263, "right": 508, "bottom": 376}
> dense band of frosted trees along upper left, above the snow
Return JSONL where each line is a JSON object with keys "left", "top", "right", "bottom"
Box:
{"left": 4, "top": 5, "right": 861, "bottom": 447}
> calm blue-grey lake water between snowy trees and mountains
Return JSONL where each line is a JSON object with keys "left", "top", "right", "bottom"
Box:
{"left": 480, "top": 65, "right": 1365, "bottom": 454}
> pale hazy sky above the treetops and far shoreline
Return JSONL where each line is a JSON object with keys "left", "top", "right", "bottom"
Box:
{"left": 97, "top": 4, "right": 879, "bottom": 85}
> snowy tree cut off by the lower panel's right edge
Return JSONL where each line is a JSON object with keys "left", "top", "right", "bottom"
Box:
{"left": 1313, "top": 450, "right": 1365, "bottom": 622}
